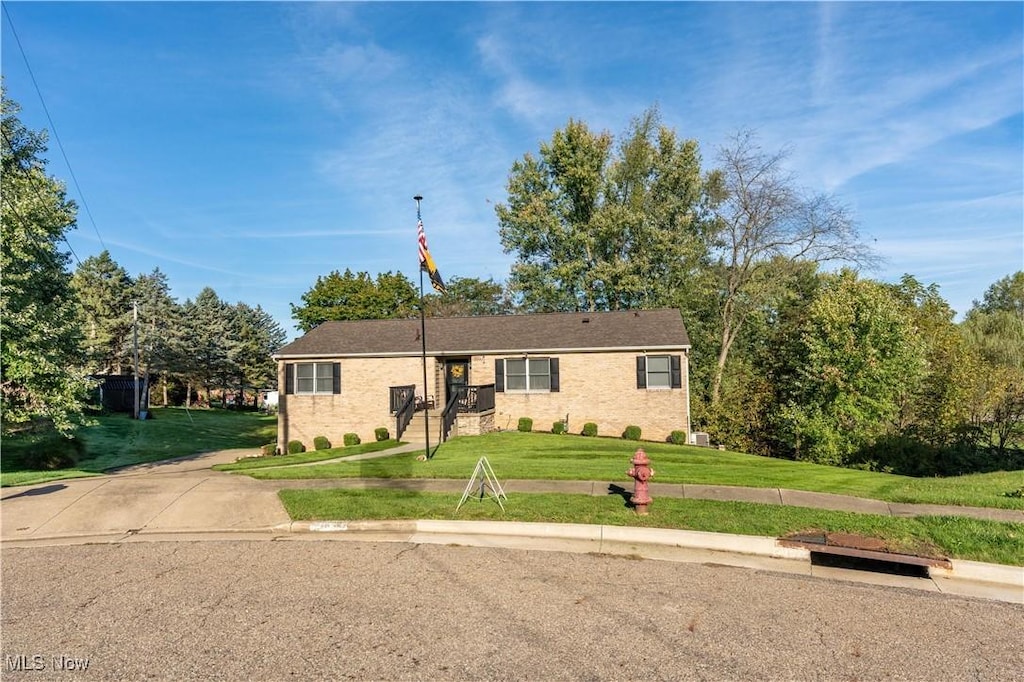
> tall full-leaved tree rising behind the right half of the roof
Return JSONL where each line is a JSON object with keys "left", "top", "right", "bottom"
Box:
{"left": 496, "top": 110, "right": 709, "bottom": 311}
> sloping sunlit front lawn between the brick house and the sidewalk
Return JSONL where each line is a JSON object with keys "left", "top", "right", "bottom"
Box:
{"left": 243, "top": 431, "right": 1024, "bottom": 509}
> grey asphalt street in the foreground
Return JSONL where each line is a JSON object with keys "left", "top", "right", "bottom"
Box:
{"left": 0, "top": 536, "right": 1024, "bottom": 681}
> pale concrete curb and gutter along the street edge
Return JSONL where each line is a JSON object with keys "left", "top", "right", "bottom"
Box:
{"left": 2, "top": 519, "right": 1024, "bottom": 604}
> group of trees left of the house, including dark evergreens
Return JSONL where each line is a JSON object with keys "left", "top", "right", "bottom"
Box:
{"left": 0, "top": 93, "right": 286, "bottom": 435}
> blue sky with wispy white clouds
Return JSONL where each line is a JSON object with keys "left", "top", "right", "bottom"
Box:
{"left": 2, "top": 2, "right": 1024, "bottom": 336}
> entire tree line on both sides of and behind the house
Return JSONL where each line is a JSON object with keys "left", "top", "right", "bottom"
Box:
{"left": 0, "top": 90, "right": 1024, "bottom": 475}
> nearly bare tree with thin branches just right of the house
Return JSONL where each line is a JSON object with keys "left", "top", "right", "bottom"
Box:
{"left": 711, "top": 131, "right": 873, "bottom": 404}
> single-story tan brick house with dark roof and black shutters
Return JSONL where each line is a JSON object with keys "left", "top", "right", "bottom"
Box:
{"left": 273, "top": 309, "right": 690, "bottom": 452}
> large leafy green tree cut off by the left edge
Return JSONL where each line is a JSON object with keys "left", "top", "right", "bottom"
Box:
{"left": 0, "top": 91, "right": 89, "bottom": 435}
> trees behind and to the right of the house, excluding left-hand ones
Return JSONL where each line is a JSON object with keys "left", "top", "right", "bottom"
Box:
{"left": 293, "top": 109, "right": 1024, "bottom": 475}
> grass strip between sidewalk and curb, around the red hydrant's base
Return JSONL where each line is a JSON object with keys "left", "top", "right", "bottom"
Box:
{"left": 279, "top": 489, "right": 1024, "bottom": 565}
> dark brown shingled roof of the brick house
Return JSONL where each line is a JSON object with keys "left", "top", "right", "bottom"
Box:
{"left": 275, "top": 308, "right": 690, "bottom": 357}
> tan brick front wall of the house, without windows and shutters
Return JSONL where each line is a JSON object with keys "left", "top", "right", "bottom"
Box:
{"left": 278, "top": 350, "right": 689, "bottom": 452}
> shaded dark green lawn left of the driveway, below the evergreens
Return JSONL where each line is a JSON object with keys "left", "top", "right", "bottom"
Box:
{"left": 0, "top": 408, "right": 278, "bottom": 486}
